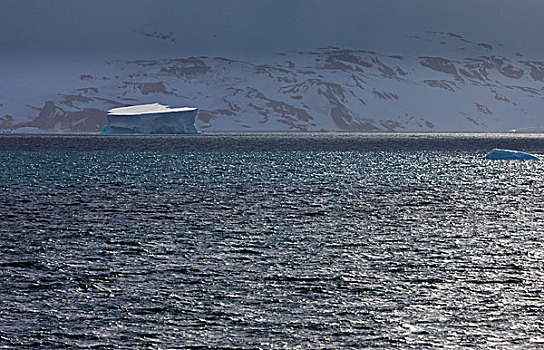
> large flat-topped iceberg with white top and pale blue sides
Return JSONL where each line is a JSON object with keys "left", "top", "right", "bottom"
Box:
{"left": 102, "top": 103, "right": 199, "bottom": 134}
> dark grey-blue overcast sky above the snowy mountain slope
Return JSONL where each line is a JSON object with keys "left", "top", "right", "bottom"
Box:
{"left": 0, "top": 0, "right": 544, "bottom": 57}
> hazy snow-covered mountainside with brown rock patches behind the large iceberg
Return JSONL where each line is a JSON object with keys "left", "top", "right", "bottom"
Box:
{"left": 0, "top": 32, "right": 544, "bottom": 132}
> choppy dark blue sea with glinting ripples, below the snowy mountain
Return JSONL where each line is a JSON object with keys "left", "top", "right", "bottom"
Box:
{"left": 0, "top": 135, "right": 544, "bottom": 349}
